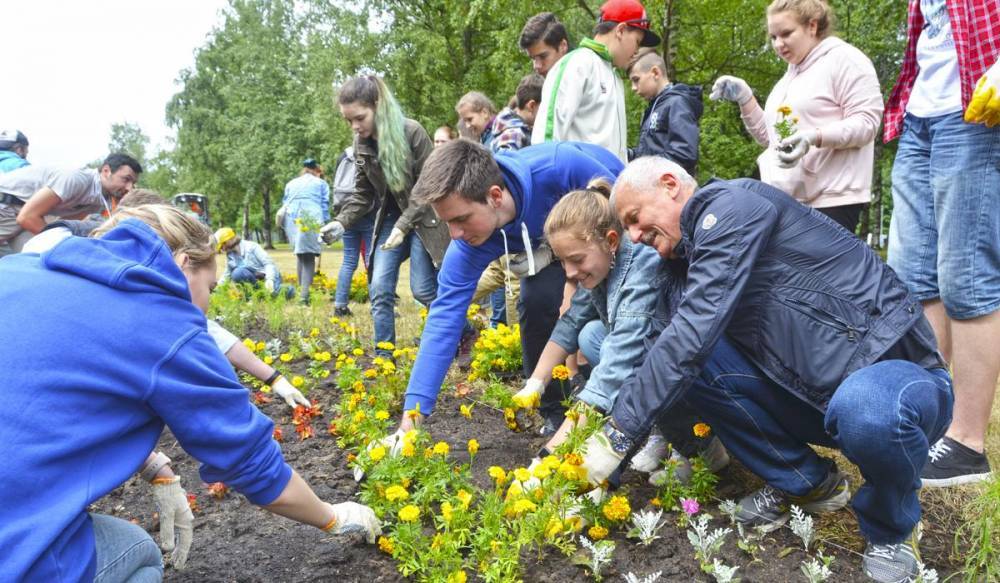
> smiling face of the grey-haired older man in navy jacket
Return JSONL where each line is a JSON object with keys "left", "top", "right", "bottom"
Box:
{"left": 615, "top": 180, "right": 686, "bottom": 259}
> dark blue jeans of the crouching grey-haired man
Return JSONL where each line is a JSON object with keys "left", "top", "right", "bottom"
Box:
{"left": 685, "top": 339, "right": 954, "bottom": 544}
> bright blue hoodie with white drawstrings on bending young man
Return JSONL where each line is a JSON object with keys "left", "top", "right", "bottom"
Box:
{"left": 404, "top": 142, "right": 622, "bottom": 415}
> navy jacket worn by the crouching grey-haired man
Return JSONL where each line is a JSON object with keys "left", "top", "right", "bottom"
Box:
{"left": 612, "top": 179, "right": 943, "bottom": 440}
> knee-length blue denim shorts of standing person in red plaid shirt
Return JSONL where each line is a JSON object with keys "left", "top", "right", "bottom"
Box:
{"left": 889, "top": 112, "right": 1000, "bottom": 320}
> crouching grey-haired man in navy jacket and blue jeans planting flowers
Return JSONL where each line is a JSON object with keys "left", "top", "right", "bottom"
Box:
{"left": 584, "top": 157, "right": 953, "bottom": 581}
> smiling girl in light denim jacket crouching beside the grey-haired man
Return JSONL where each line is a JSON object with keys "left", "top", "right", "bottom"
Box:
{"left": 514, "top": 179, "right": 729, "bottom": 488}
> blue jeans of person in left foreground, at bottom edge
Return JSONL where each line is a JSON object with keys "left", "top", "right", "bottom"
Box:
{"left": 90, "top": 514, "right": 163, "bottom": 583}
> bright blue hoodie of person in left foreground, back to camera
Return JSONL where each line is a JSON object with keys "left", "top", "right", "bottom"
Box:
{"left": 0, "top": 220, "right": 291, "bottom": 581}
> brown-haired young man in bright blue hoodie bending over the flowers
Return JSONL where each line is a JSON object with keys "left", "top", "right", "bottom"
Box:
{"left": 392, "top": 140, "right": 622, "bottom": 431}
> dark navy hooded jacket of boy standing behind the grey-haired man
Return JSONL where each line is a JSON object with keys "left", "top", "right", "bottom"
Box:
{"left": 629, "top": 83, "right": 704, "bottom": 176}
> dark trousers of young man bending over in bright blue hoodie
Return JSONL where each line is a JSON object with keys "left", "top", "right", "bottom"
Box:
{"left": 517, "top": 262, "right": 571, "bottom": 426}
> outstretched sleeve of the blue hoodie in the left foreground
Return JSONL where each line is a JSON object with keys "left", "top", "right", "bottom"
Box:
{"left": 147, "top": 330, "right": 292, "bottom": 505}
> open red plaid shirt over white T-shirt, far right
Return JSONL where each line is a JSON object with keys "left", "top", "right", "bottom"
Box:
{"left": 885, "top": 0, "right": 1000, "bottom": 142}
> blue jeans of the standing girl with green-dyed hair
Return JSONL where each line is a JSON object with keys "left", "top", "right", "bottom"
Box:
{"left": 368, "top": 215, "right": 437, "bottom": 355}
